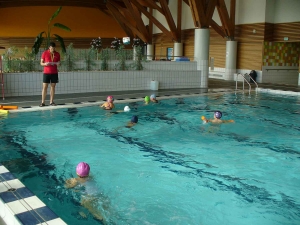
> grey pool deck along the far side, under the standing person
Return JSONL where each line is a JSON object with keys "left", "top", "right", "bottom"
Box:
{"left": 0, "top": 78, "right": 300, "bottom": 109}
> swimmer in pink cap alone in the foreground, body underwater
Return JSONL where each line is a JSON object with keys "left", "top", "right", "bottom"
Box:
{"left": 65, "top": 162, "right": 107, "bottom": 223}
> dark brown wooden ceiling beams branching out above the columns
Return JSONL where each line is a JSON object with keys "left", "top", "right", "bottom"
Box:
{"left": 0, "top": 0, "right": 236, "bottom": 43}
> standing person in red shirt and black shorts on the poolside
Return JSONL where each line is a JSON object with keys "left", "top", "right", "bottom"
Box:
{"left": 40, "top": 42, "right": 60, "bottom": 107}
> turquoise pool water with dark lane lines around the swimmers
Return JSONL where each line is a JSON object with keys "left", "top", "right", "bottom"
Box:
{"left": 0, "top": 93, "right": 300, "bottom": 225}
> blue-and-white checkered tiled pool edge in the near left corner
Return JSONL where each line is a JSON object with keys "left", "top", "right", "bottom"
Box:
{"left": 0, "top": 163, "right": 67, "bottom": 225}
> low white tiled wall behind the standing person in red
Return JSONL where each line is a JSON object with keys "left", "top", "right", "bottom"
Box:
{"left": 4, "top": 70, "right": 201, "bottom": 97}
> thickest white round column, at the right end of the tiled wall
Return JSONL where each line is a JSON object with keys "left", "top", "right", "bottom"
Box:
{"left": 194, "top": 28, "right": 210, "bottom": 88}
